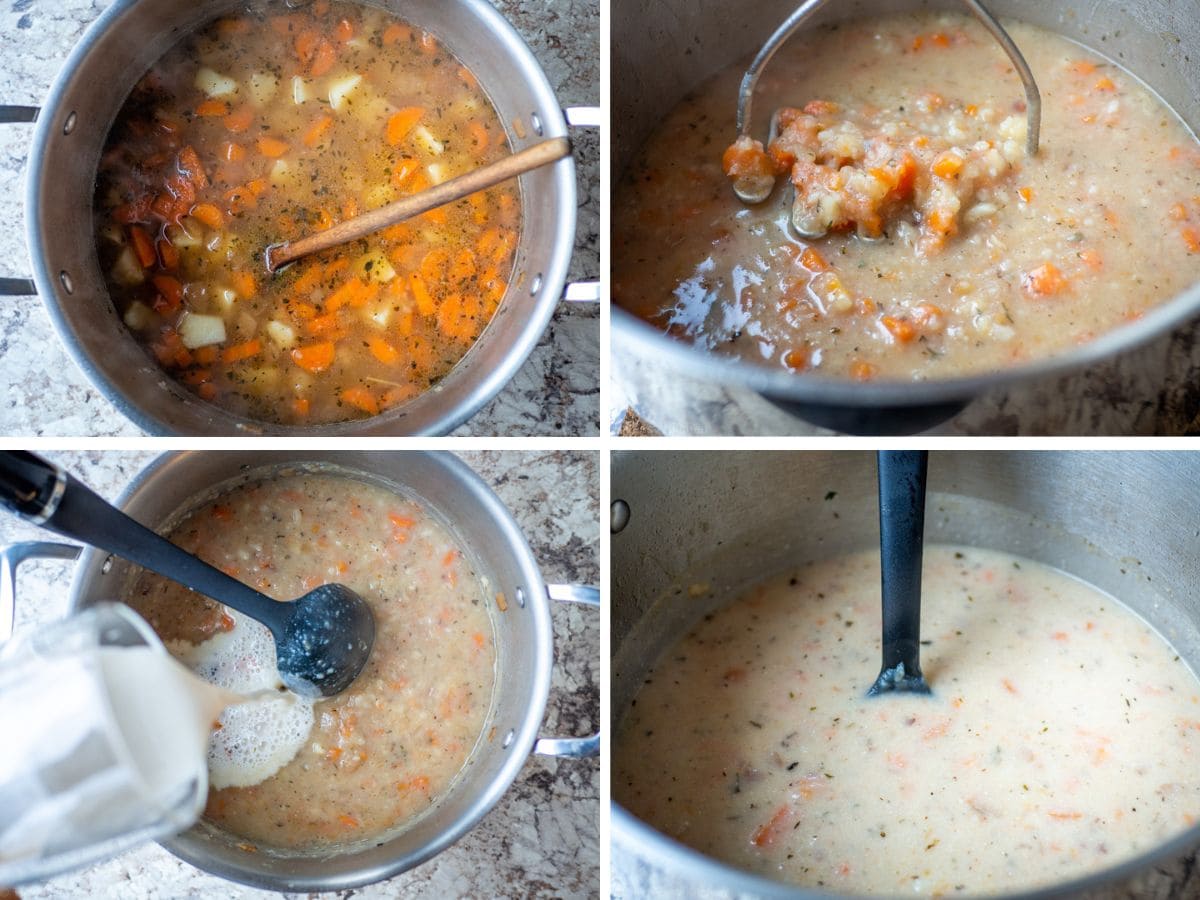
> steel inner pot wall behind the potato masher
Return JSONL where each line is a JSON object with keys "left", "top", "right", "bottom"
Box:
{"left": 611, "top": 0, "right": 1200, "bottom": 175}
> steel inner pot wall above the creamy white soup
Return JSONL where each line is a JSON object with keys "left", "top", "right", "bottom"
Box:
{"left": 611, "top": 451, "right": 1200, "bottom": 722}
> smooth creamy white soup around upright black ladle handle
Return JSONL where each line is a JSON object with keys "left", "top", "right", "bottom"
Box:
{"left": 612, "top": 547, "right": 1200, "bottom": 896}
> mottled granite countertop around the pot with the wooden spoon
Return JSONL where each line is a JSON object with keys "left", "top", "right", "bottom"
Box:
{"left": 0, "top": 0, "right": 600, "bottom": 436}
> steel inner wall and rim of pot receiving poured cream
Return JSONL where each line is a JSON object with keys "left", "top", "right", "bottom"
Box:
{"left": 72, "top": 451, "right": 552, "bottom": 890}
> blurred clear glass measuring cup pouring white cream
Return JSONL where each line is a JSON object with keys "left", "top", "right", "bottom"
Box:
{"left": 0, "top": 604, "right": 211, "bottom": 886}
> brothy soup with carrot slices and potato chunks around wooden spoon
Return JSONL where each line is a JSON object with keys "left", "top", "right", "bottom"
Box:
{"left": 96, "top": 0, "right": 520, "bottom": 425}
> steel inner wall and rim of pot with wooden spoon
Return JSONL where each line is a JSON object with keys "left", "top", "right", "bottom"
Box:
{"left": 29, "top": 0, "right": 575, "bottom": 434}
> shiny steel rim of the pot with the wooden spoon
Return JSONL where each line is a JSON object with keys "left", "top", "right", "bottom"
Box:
{"left": 24, "top": 0, "right": 577, "bottom": 437}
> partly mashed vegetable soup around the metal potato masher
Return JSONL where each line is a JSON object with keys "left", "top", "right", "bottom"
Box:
{"left": 613, "top": 13, "right": 1200, "bottom": 380}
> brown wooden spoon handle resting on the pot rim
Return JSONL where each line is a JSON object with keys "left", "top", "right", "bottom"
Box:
{"left": 265, "top": 138, "right": 571, "bottom": 274}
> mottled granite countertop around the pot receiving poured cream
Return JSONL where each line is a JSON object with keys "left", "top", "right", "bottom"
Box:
{"left": 0, "top": 451, "right": 600, "bottom": 900}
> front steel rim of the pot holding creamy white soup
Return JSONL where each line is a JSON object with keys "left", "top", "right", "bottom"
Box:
{"left": 611, "top": 800, "right": 1200, "bottom": 900}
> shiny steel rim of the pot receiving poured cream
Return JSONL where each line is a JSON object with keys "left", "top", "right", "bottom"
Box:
{"left": 67, "top": 450, "right": 553, "bottom": 892}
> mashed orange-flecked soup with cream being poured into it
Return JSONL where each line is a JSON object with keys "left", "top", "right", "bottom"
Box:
{"left": 126, "top": 472, "right": 496, "bottom": 850}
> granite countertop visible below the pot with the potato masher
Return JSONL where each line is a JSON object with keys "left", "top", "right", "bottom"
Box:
{"left": 606, "top": 323, "right": 1200, "bottom": 437}
